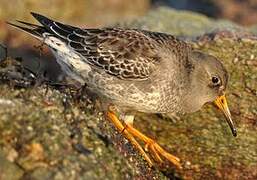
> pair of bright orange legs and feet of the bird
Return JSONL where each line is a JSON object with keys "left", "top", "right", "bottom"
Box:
{"left": 107, "top": 110, "right": 181, "bottom": 168}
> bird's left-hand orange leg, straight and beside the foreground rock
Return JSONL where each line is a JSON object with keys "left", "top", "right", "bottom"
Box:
{"left": 107, "top": 110, "right": 153, "bottom": 167}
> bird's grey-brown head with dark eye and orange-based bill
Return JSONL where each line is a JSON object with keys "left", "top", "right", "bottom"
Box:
{"left": 181, "top": 51, "right": 237, "bottom": 136}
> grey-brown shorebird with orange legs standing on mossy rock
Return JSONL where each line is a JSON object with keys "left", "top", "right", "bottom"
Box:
{"left": 7, "top": 12, "right": 237, "bottom": 168}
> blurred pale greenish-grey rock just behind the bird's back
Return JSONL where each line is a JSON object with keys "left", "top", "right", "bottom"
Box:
{"left": 119, "top": 7, "right": 244, "bottom": 38}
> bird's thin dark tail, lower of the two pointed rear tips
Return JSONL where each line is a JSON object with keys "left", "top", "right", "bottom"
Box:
{"left": 6, "top": 18, "right": 47, "bottom": 40}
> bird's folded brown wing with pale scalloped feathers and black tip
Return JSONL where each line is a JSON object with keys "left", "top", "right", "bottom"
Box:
{"left": 26, "top": 13, "right": 164, "bottom": 80}
